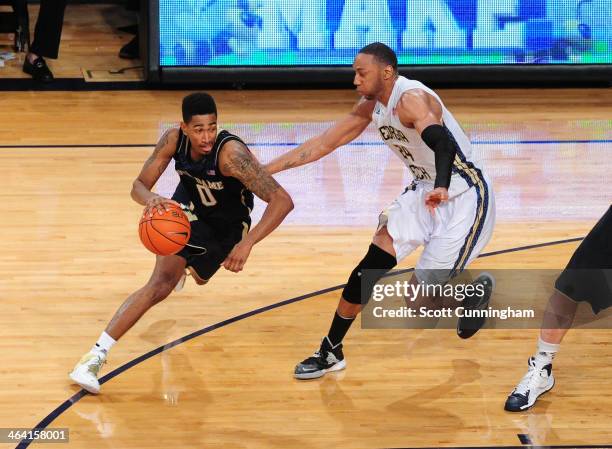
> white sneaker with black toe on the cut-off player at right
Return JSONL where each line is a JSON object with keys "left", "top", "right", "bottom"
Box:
{"left": 504, "top": 357, "right": 555, "bottom": 412}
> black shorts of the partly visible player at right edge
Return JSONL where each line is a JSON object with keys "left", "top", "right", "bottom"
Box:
{"left": 555, "top": 206, "right": 612, "bottom": 313}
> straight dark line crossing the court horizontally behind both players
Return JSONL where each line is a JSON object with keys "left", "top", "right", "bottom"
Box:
{"left": 0, "top": 139, "right": 612, "bottom": 149}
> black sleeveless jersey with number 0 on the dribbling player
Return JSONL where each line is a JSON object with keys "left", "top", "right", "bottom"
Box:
{"left": 172, "top": 129, "right": 253, "bottom": 227}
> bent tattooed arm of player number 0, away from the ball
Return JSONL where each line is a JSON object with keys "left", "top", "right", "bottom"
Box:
{"left": 219, "top": 140, "right": 293, "bottom": 272}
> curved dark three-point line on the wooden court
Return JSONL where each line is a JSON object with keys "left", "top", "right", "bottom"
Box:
{"left": 15, "top": 237, "right": 592, "bottom": 449}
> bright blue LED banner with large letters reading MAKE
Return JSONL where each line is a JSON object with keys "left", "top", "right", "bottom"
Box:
{"left": 159, "top": 0, "right": 612, "bottom": 68}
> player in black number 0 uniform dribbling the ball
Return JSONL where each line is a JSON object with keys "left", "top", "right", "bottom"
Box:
{"left": 70, "top": 93, "right": 293, "bottom": 394}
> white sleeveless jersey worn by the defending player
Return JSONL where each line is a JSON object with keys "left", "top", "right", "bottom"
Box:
{"left": 372, "top": 76, "right": 485, "bottom": 197}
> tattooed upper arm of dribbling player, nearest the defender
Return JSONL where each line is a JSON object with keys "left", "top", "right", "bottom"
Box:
{"left": 222, "top": 142, "right": 280, "bottom": 201}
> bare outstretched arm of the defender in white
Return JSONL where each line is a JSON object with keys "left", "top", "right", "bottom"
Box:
{"left": 266, "top": 99, "right": 376, "bottom": 174}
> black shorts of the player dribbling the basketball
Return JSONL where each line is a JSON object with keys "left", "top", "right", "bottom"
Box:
{"left": 176, "top": 213, "right": 250, "bottom": 281}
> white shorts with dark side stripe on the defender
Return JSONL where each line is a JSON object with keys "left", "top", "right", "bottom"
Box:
{"left": 379, "top": 178, "right": 495, "bottom": 281}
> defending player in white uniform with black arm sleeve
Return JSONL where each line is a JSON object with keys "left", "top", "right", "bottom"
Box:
{"left": 266, "top": 43, "right": 495, "bottom": 379}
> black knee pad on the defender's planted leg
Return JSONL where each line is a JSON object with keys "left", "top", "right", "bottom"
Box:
{"left": 342, "top": 243, "right": 397, "bottom": 304}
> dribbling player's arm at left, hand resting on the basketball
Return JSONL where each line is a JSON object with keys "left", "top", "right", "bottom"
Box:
{"left": 131, "top": 128, "right": 178, "bottom": 215}
